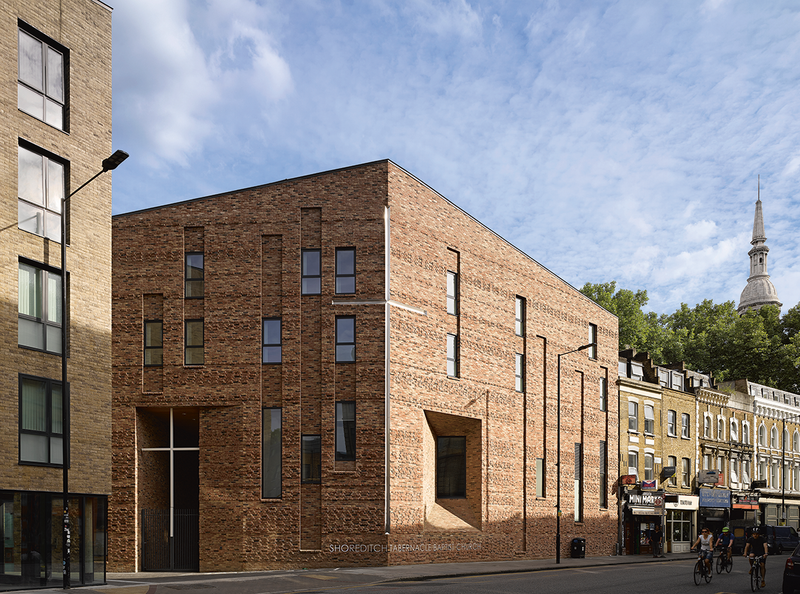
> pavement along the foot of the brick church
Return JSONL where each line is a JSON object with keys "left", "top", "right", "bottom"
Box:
{"left": 20, "top": 553, "right": 697, "bottom": 594}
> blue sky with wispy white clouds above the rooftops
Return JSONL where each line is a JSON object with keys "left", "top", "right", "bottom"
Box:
{"left": 109, "top": 0, "right": 800, "bottom": 313}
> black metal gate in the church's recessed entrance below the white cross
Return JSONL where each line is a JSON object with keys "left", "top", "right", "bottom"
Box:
{"left": 142, "top": 509, "right": 200, "bottom": 571}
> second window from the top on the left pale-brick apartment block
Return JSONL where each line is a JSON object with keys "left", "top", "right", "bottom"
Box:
{"left": 17, "top": 146, "right": 65, "bottom": 243}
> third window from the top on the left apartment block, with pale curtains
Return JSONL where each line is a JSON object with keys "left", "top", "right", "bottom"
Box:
{"left": 17, "top": 262, "right": 62, "bottom": 354}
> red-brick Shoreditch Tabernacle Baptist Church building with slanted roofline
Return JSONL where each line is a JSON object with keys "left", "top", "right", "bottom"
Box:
{"left": 109, "top": 161, "right": 619, "bottom": 571}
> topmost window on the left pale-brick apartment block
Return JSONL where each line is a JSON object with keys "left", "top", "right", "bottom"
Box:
{"left": 17, "top": 29, "right": 67, "bottom": 130}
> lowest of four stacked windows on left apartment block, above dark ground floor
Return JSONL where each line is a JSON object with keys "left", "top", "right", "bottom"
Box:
{"left": 19, "top": 375, "right": 64, "bottom": 466}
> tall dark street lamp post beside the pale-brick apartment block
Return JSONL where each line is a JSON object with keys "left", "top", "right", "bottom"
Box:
{"left": 61, "top": 151, "right": 128, "bottom": 590}
